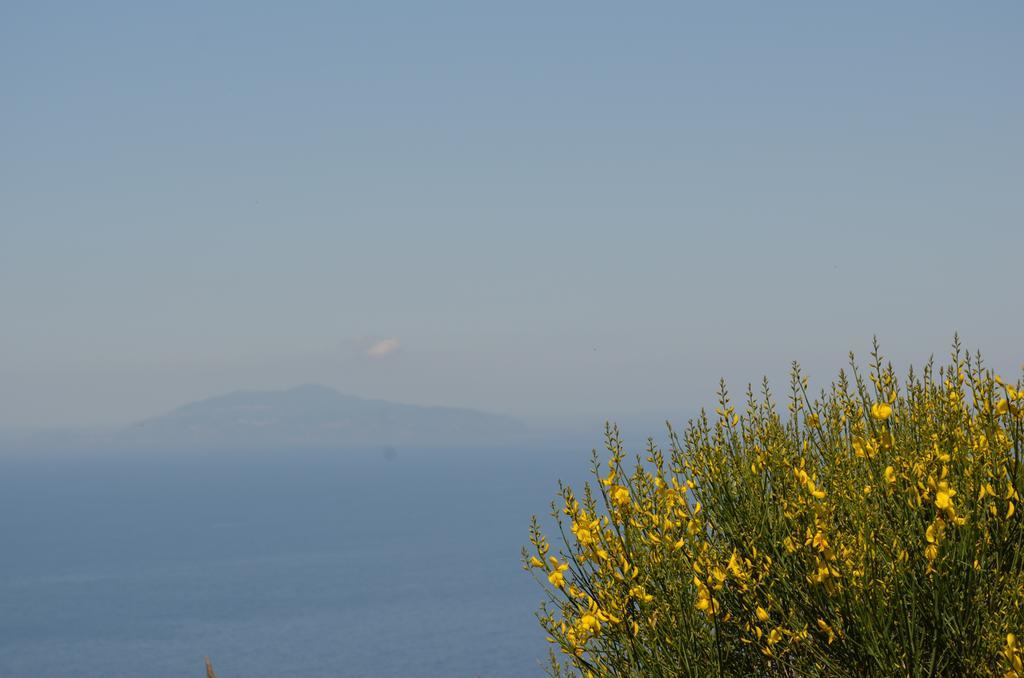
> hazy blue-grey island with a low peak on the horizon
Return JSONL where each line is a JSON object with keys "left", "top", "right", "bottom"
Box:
{"left": 0, "top": 384, "right": 527, "bottom": 451}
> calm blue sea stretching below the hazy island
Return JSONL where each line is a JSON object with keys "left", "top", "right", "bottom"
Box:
{"left": 0, "top": 449, "right": 589, "bottom": 678}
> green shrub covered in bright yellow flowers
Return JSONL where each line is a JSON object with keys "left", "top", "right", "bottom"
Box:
{"left": 522, "top": 340, "right": 1024, "bottom": 676}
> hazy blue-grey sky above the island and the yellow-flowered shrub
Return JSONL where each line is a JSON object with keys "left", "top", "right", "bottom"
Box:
{"left": 0, "top": 2, "right": 1024, "bottom": 426}
